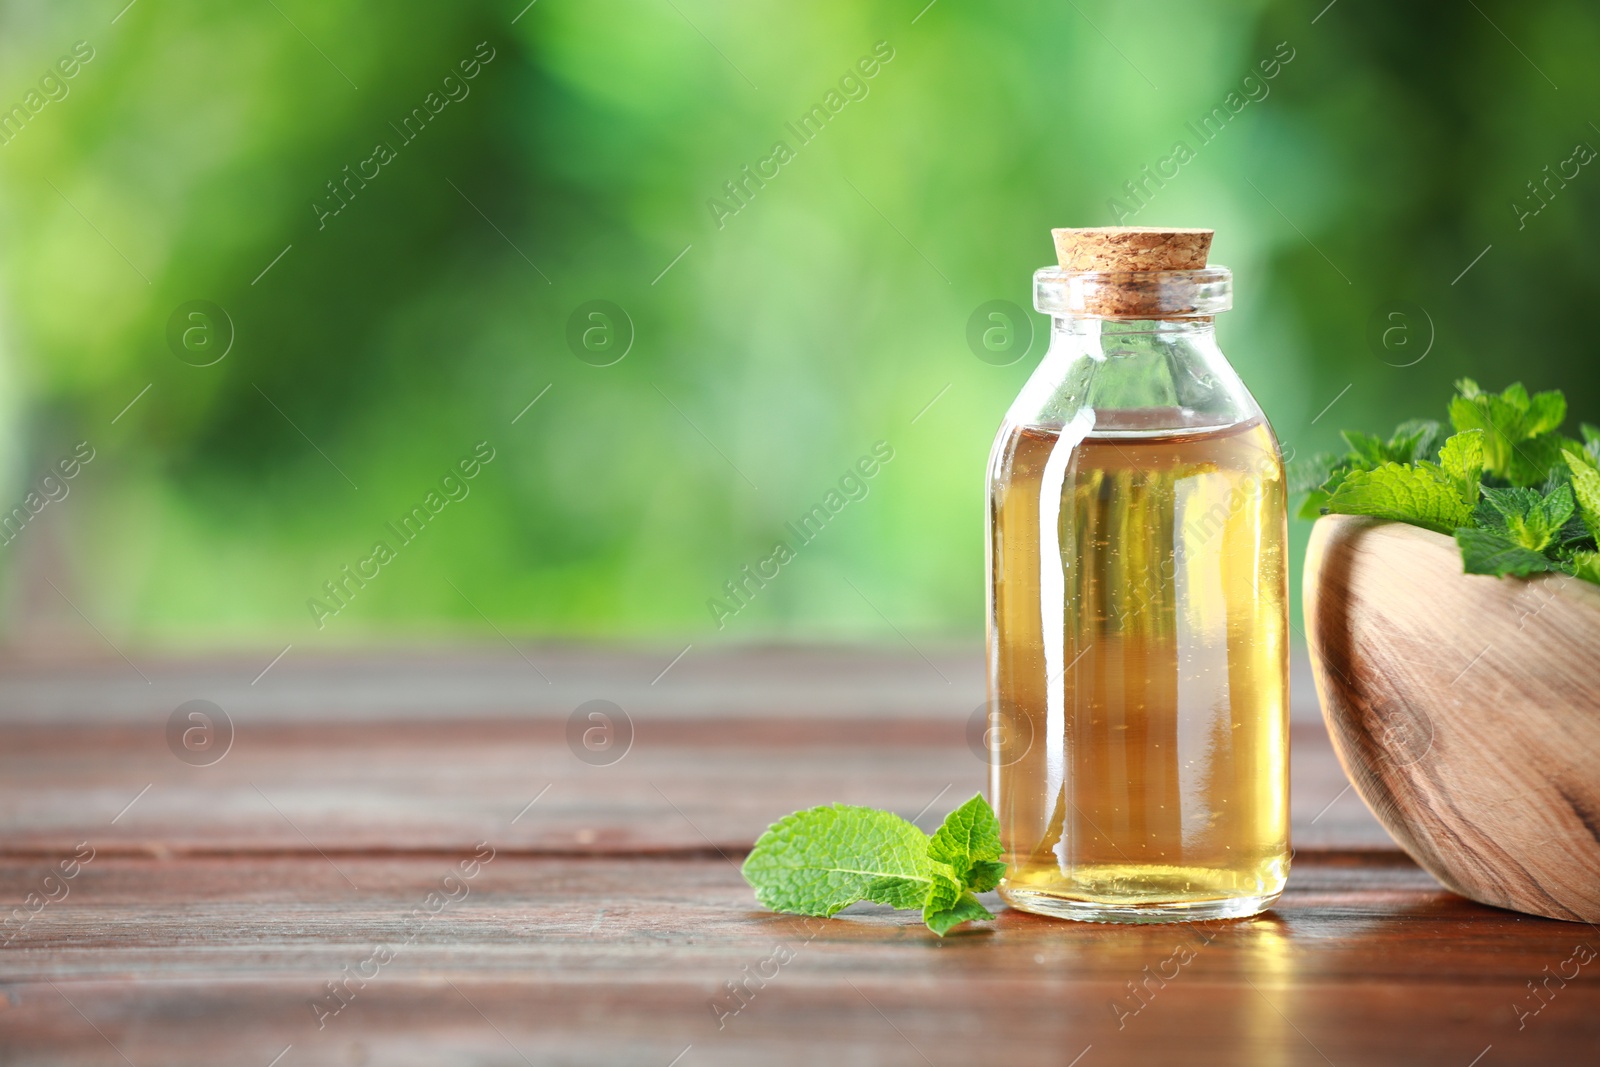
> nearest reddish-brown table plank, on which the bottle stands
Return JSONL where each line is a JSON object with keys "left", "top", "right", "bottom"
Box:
{"left": 0, "top": 853, "right": 1600, "bottom": 1067}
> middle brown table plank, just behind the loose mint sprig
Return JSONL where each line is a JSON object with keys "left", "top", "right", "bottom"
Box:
{"left": 0, "top": 723, "right": 1392, "bottom": 854}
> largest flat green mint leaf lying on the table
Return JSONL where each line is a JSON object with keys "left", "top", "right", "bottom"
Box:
{"left": 744, "top": 805, "right": 934, "bottom": 915}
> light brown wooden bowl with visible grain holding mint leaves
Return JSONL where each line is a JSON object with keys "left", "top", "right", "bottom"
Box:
{"left": 1306, "top": 515, "right": 1600, "bottom": 923}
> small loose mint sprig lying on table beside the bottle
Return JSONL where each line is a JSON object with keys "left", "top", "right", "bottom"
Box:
{"left": 744, "top": 795, "right": 1005, "bottom": 937}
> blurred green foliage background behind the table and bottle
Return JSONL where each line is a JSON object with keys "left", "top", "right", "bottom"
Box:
{"left": 0, "top": 0, "right": 1600, "bottom": 645}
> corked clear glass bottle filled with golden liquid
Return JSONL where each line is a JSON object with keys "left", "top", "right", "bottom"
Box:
{"left": 987, "top": 227, "right": 1290, "bottom": 923}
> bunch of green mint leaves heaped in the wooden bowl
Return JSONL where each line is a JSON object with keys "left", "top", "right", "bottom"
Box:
{"left": 1296, "top": 378, "right": 1600, "bottom": 584}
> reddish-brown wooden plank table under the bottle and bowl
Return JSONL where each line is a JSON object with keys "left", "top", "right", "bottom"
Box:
{"left": 0, "top": 648, "right": 1600, "bottom": 1067}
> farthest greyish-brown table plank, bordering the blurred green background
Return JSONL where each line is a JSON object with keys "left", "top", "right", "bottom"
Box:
{"left": 0, "top": 638, "right": 985, "bottom": 726}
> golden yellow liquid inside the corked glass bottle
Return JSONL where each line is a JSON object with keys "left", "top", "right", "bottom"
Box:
{"left": 989, "top": 411, "right": 1288, "bottom": 921}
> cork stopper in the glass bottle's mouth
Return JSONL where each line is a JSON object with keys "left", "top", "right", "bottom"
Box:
{"left": 1040, "top": 226, "right": 1230, "bottom": 318}
